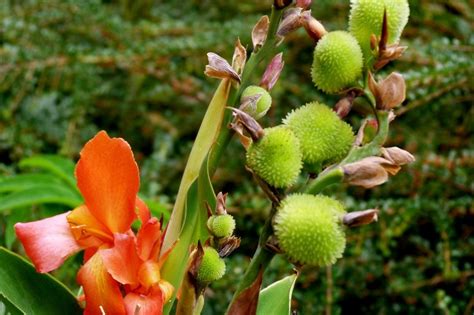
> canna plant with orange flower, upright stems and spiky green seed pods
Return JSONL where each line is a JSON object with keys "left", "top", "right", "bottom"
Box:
{"left": 0, "top": 0, "right": 414, "bottom": 314}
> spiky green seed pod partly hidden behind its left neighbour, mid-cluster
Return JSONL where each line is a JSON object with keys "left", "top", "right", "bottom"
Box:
{"left": 283, "top": 102, "right": 354, "bottom": 165}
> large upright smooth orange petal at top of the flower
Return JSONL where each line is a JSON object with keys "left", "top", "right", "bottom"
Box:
{"left": 76, "top": 131, "right": 140, "bottom": 233}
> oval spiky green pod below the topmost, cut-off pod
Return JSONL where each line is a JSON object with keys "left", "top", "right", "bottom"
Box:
{"left": 311, "top": 31, "right": 363, "bottom": 93}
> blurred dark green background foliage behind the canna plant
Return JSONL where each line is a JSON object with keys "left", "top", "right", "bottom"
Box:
{"left": 0, "top": 0, "right": 474, "bottom": 315}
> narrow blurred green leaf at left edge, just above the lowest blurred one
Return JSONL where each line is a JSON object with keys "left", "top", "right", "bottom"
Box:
{"left": 0, "top": 174, "right": 61, "bottom": 193}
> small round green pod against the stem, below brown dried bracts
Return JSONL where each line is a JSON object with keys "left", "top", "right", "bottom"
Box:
{"left": 240, "top": 85, "right": 272, "bottom": 119}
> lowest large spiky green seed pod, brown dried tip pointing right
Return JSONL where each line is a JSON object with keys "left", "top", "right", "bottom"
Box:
{"left": 273, "top": 194, "right": 346, "bottom": 266}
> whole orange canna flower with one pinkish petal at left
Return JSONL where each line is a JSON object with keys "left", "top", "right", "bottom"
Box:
{"left": 15, "top": 131, "right": 172, "bottom": 314}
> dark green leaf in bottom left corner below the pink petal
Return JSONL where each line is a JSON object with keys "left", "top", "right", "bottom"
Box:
{"left": 0, "top": 247, "right": 82, "bottom": 315}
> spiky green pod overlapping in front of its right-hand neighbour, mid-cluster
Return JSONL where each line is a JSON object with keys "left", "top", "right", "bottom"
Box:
{"left": 247, "top": 126, "right": 302, "bottom": 188}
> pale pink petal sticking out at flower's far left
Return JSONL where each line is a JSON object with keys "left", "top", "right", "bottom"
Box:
{"left": 15, "top": 212, "right": 81, "bottom": 273}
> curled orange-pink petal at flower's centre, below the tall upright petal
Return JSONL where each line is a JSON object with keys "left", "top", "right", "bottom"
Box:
{"left": 100, "top": 233, "right": 142, "bottom": 287}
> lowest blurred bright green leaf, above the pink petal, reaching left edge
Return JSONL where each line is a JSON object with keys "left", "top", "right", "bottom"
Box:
{"left": 0, "top": 184, "right": 82, "bottom": 212}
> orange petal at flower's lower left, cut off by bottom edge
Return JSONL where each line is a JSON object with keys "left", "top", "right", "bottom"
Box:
{"left": 77, "top": 251, "right": 125, "bottom": 315}
